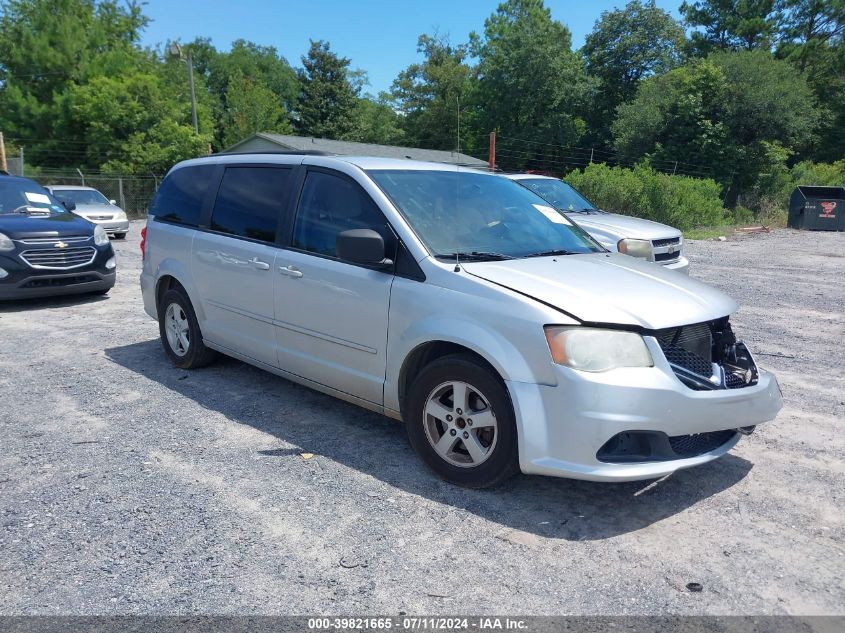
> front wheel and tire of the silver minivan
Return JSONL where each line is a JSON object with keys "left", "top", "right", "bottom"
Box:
{"left": 403, "top": 354, "right": 519, "bottom": 488}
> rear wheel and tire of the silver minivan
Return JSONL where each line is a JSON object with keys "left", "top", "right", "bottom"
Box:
{"left": 158, "top": 288, "right": 217, "bottom": 369}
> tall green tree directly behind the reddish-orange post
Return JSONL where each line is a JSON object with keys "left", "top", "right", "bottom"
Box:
{"left": 474, "top": 0, "right": 590, "bottom": 167}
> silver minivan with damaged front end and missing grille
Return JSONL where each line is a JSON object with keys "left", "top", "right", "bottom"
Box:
{"left": 141, "top": 154, "right": 782, "bottom": 487}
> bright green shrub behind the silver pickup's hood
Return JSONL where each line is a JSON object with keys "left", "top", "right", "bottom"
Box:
{"left": 566, "top": 163, "right": 731, "bottom": 230}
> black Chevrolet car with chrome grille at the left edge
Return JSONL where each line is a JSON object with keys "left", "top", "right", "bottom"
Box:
{"left": 0, "top": 174, "right": 116, "bottom": 300}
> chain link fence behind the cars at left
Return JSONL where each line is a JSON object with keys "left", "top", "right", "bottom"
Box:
{"left": 25, "top": 167, "right": 160, "bottom": 218}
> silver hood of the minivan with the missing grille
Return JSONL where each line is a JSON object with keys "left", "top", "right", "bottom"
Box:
{"left": 461, "top": 253, "right": 738, "bottom": 330}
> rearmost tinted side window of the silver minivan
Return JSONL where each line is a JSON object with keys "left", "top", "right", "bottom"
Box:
{"left": 150, "top": 165, "right": 215, "bottom": 226}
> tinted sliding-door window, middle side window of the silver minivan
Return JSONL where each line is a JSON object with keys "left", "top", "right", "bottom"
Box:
{"left": 211, "top": 167, "right": 290, "bottom": 242}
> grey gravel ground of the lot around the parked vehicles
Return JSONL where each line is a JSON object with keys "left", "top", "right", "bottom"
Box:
{"left": 0, "top": 223, "right": 845, "bottom": 615}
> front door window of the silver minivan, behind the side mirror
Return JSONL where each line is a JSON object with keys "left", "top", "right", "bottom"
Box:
{"left": 293, "top": 171, "right": 395, "bottom": 257}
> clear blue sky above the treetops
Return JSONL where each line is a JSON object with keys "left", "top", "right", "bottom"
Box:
{"left": 138, "top": 0, "right": 680, "bottom": 94}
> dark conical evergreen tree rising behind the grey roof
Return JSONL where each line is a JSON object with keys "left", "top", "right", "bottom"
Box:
{"left": 296, "top": 40, "right": 358, "bottom": 139}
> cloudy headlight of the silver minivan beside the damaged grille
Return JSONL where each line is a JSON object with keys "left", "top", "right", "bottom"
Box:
{"left": 544, "top": 325, "right": 654, "bottom": 371}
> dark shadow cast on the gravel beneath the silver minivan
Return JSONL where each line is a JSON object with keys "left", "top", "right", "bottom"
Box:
{"left": 105, "top": 339, "right": 752, "bottom": 541}
